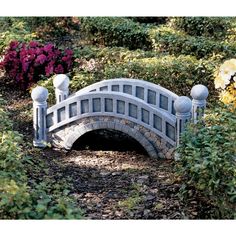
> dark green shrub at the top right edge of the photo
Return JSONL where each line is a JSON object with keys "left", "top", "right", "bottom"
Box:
{"left": 170, "top": 17, "right": 232, "bottom": 39}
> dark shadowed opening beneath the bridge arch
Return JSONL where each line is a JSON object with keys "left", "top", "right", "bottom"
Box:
{"left": 72, "top": 129, "right": 148, "bottom": 155}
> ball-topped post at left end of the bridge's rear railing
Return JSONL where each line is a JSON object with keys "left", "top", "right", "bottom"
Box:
{"left": 53, "top": 74, "right": 70, "bottom": 103}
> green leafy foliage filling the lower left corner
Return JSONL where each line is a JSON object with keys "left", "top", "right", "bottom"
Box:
{"left": 0, "top": 99, "right": 82, "bottom": 219}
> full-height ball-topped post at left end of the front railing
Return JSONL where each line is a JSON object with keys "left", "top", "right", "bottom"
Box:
{"left": 31, "top": 86, "right": 48, "bottom": 147}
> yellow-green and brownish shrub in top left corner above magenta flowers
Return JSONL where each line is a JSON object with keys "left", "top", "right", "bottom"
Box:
{"left": 0, "top": 17, "right": 80, "bottom": 53}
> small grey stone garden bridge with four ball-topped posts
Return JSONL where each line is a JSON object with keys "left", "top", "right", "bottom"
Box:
{"left": 32, "top": 75, "right": 208, "bottom": 159}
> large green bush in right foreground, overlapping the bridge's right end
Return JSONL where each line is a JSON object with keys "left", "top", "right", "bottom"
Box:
{"left": 177, "top": 107, "right": 236, "bottom": 218}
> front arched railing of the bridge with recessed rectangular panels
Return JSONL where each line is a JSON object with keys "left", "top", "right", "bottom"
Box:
{"left": 46, "top": 92, "right": 176, "bottom": 146}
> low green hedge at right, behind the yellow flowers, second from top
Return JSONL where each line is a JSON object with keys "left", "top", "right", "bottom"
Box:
{"left": 150, "top": 27, "right": 236, "bottom": 58}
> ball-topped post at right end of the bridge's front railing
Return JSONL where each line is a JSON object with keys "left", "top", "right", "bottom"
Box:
{"left": 174, "top": 96, "right": 192, "bottom": 146}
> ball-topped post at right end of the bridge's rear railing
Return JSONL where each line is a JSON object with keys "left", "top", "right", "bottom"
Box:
{"left": 191, "top": 84, "right": 209, "bottom": 124}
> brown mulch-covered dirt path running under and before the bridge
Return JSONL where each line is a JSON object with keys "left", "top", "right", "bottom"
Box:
{"left": 0, "top": 79, "right": 216, "bottom": 219}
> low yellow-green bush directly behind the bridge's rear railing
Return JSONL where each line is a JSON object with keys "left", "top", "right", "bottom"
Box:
{"left": 103, "top": 56, "right": 215, "bottom": 95}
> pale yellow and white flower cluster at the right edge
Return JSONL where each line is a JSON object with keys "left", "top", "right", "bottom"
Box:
{"left": 215, "top": 59, "right": 236, "bottom": 107}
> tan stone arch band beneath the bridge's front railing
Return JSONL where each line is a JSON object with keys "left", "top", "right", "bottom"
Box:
{"left": 49, "top": 116, "right": 174, "bottom": 159}
